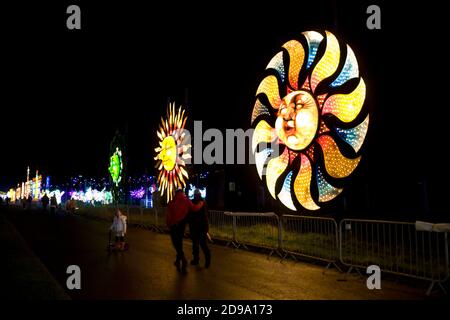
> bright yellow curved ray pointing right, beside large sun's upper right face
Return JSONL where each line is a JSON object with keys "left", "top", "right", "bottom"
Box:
{"left": 322, "top": 78, "right": 366, "bottom": 122}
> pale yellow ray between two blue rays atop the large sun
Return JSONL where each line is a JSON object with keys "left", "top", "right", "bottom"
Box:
{"left": 311, "top": 31, "right": 340, "bottom": 92}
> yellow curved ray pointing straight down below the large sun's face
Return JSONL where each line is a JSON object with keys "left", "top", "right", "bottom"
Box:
{"left": 294, "top": 154, "right": 320, "bottom": 210}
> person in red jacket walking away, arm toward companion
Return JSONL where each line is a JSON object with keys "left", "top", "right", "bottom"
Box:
{"left": 166, "top": 189, "right": 203, "bottom": 272}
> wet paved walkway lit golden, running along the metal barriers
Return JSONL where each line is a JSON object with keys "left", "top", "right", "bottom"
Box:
{"left": 2, "top": 211, "right": 427, "bottom": 300}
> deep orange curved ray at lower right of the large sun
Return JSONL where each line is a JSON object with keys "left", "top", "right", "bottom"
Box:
{"left": 317, "top": 135, "right": 361, "bottom": 178}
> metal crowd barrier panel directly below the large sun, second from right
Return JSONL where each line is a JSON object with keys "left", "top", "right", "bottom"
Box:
{"left": 281, "top": 215, "right": 341, "bottom": 271}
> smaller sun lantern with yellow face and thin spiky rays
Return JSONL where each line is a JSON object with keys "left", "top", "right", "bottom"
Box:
{"left": 155, "top": 103, "right": 191, "bottom": 202}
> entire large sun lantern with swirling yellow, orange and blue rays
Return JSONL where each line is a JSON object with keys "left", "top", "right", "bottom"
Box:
{"left": 252, "top": 31, "right": 369, "bottom": 210}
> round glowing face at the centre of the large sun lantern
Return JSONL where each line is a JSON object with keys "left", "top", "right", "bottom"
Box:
{"left": 275, "top": 90, "right": 319, "bottom": 150}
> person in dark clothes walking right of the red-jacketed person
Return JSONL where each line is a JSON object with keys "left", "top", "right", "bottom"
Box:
{"left": 188, "top": 189, "right": 211, "bottom": 268}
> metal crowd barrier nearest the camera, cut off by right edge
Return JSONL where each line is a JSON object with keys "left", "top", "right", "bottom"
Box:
{"left": 339, "top": 219, "right": 449, "bottom": 295}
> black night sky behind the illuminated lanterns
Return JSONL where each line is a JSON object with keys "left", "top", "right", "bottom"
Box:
{"left": 0, "top": 1, "right": 449, "bottom": 220}
